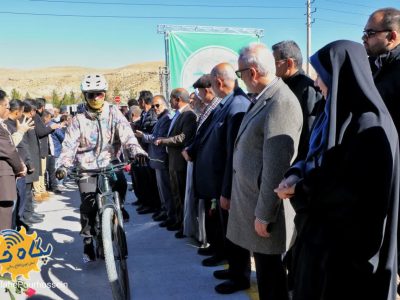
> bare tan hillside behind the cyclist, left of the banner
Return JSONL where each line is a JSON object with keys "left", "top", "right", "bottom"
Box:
{"left": 0, "top": 62, "right": 164, "bottom": 102}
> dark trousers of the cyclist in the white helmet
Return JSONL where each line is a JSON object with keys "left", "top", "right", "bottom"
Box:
{"left": 78, "top": 171, "right": 127, "bottom": 238}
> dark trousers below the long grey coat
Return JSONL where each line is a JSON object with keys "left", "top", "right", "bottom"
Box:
{"left": 253, "top": 253, "right": 289, "bottom": 300}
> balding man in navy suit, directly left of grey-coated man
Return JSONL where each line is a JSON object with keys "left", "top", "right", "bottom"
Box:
{"left": 190, "top": 63, "right": 250, "bottom": 294}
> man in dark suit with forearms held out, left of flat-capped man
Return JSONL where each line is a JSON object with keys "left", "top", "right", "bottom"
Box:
{"left": 155, "top": 88, "right": 197, "bottom": 237}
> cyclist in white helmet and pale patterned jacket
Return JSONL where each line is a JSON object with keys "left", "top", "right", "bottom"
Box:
{"left": 56, "top": 74, "right": 147, "bottom": 262}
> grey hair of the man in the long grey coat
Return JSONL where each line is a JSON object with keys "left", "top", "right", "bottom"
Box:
{"left": 239, "top": 43, "right": 276, "bottom": 78}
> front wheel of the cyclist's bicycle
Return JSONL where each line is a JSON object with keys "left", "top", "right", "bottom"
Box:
{"left": 102, "top": 207, "right": 130, "bottom": 300}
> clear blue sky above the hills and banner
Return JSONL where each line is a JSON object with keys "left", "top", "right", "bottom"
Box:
{"left": 0, "top": 0, "right": 400, "bottom": 68}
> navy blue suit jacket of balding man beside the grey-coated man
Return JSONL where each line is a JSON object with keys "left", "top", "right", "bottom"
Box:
{"left": 189, "top": 88, "right": 250, "bottom": 199}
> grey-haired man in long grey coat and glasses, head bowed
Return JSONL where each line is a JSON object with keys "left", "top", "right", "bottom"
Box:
{"left": 227, "top": 44, "right": 303, "bottom": 300}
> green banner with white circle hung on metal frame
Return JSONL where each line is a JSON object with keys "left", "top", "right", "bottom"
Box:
{"left": 168, "top": 31, "right": 259, "bottom": 91}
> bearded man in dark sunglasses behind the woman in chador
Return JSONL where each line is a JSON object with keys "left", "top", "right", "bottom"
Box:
{"left": 362, "top": 8, "right": 400, "bottom": 132}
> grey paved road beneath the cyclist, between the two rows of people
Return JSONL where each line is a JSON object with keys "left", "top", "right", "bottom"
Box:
{"left": 0, "top": 179, "right": 258, "bottom": 300}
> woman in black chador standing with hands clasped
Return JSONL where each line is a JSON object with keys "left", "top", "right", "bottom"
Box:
{"left": 275, "top": 41, "right": 400, "bottom": 300}
